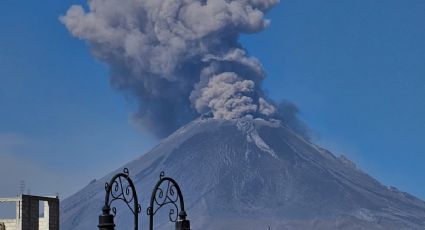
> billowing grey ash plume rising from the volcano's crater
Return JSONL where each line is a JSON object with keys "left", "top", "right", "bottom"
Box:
{"left": 60, "top": 0, "right": 278, "bottom": 136}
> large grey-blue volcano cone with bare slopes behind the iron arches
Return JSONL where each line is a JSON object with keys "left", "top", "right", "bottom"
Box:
{"left": 61, "top": 118, "right": 425, "bottom": 230}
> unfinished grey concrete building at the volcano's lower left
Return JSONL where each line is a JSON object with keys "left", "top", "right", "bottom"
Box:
{"left": 0, "top": 195, "right": 59, "bottom": 230}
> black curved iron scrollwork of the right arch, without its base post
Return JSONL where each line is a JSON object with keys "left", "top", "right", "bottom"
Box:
{"left": 147, "top": 172, "right": 186, "bottom": 230}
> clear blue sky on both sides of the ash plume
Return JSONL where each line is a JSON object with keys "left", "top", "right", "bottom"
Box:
{"left": 0, "top": 0, "right": 425, "bottom": 199}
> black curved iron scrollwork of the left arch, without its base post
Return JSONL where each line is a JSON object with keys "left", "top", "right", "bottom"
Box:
{"left": 102, "top": 168, "right": 141, "bottom": 230}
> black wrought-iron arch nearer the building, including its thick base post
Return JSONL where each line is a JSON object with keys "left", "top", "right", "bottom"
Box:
{"left": 98, "top": 168, "right": 141, "bottom": 230}
